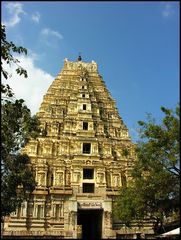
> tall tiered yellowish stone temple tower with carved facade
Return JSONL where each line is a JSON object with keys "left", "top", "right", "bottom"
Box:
{"left": 3, "top": 56, "right": 152, "bottom": 239}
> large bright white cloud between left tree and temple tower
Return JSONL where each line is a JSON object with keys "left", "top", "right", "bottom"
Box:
{"left": 3, "top": 56, "right": 54, "bottom": 114}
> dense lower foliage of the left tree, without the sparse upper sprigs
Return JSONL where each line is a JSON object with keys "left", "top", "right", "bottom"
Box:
{"left": 1, "top": 99, "right": 40, "bottom": 216}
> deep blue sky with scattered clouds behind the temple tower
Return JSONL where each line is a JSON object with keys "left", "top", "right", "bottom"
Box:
{"left": 2, "top": 1, "right": 180, "bottom": 141}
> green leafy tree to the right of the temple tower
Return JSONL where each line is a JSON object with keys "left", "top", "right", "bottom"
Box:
{"left": 114, "top": 105, "right": 180, "bottom": 232}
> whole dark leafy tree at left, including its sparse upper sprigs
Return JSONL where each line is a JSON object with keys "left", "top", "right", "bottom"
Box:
{"left": 1, "top": 25, "right": 40, "bottom": 221}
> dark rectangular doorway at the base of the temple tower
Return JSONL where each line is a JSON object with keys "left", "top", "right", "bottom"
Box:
{"left": 77, "top": 209, "right": 103, "bottom": 239}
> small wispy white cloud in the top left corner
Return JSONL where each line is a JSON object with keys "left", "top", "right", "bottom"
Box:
{"left": 4, "top": 2, "right": 26, "bottom": 27}
